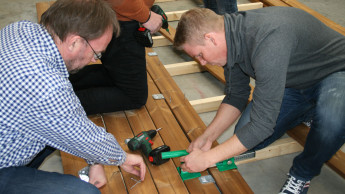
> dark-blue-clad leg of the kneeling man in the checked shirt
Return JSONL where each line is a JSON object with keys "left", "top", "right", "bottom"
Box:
{"left": 0, "top": 167, "right": 100, "bottom": 194}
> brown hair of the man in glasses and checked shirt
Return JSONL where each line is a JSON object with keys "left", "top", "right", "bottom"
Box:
{"left": 40, "top": 0, "right": 120, "bottom": 41}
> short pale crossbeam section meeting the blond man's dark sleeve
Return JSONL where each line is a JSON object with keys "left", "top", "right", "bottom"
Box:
{"left": 189, "top": 95, "right": 225, "bottom": 114}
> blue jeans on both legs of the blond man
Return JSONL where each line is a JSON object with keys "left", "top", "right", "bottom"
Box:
{"left": 235, "top": 71, "right": 345, "bottom": 180}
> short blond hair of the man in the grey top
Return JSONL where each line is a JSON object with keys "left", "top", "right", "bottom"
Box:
{"left": 174, "top": 8, "right": 224, "bottom": 50}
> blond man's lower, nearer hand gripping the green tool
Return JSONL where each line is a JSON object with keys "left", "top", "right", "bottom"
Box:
{"left": 180, "top": 148, "right": 213, "bottom": 172}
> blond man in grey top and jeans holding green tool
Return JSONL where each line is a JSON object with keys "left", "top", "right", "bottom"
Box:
{"left": 174, "top": 7, "right": 345, "bottom": 193}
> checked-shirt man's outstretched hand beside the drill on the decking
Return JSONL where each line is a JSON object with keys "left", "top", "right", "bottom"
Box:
{"left": 120, "top": 153, "right": 146, "bottom": 181}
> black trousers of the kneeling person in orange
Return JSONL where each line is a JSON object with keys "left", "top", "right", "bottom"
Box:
{"left": 70, "top": 21, "right": 148, "bottom": 115}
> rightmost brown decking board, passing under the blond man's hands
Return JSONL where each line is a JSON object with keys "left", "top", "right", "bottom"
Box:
{"left": 146, "top": 48, "right": 252, "bottom": 193}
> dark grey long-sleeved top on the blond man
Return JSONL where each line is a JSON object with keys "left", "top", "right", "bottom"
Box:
{"left": 223, "top": 7, "right": 345, "bottom": 149}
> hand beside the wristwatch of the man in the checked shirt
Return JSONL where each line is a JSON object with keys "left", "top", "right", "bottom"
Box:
{"left": 89, "top": 164, "right": 107, "bottom": 188}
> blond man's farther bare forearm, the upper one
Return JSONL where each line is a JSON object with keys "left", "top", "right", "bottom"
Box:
{"left": 204, "top": 103, "right": 241, "bottom": 142}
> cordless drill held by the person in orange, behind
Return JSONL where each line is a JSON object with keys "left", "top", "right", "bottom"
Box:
{"left": 134, "top": 5, "right": 170, "bottom": 47}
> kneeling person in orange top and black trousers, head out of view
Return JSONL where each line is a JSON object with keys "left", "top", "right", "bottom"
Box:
{"left": 70, "top": 0, "right": 162, "bottom": 115}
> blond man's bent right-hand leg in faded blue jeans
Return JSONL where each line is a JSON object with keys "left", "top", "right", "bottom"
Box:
{"left": 290, "top": 72, "right": 345, "bottom": 180}
